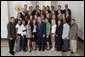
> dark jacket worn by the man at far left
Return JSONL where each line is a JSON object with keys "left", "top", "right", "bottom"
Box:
{"left": 7, "top": 22, "right": 16, "bottom": 39}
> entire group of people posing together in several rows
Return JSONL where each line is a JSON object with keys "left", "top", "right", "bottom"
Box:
{"left": 7, "top": 4, "right": 78, "bottom": 55}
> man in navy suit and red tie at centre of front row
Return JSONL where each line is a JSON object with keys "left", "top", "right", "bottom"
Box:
{"left": 37, "top": 17, "right": 45, "bottom": 51}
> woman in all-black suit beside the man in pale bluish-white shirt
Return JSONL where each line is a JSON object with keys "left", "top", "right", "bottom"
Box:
{"left": 56, "top": 20, "right": 63, "bottom": 51}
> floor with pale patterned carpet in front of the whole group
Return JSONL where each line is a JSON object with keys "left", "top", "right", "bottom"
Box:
{"left": 1, "top": 39, "right": 84, "bottom": 56}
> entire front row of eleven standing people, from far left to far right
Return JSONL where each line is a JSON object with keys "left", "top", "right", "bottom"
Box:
{"left": 7, "top": 17, "right": 78, "bottom": 55}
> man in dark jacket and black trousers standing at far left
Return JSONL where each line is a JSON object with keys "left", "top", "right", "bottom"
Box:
{"left": 7, "top": 17, "right": 16, "bottom": 55}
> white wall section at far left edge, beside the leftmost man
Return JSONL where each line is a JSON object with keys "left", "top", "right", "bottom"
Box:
{"left": 1, "top": 1, "right": 8, "bottom": 38}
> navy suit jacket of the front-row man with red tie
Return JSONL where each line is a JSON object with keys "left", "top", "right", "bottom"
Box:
{"left": 37, "top": 21, "right": 46, "bottom": 37}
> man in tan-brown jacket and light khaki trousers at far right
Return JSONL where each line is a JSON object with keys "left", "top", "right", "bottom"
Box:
{"left": 69, "top": 19, "right": 78, "bottom": 53}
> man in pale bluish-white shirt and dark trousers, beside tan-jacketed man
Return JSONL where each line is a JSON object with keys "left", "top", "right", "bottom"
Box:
{"left": 62, "top": 20, "right": 70, "bottom": 52}
